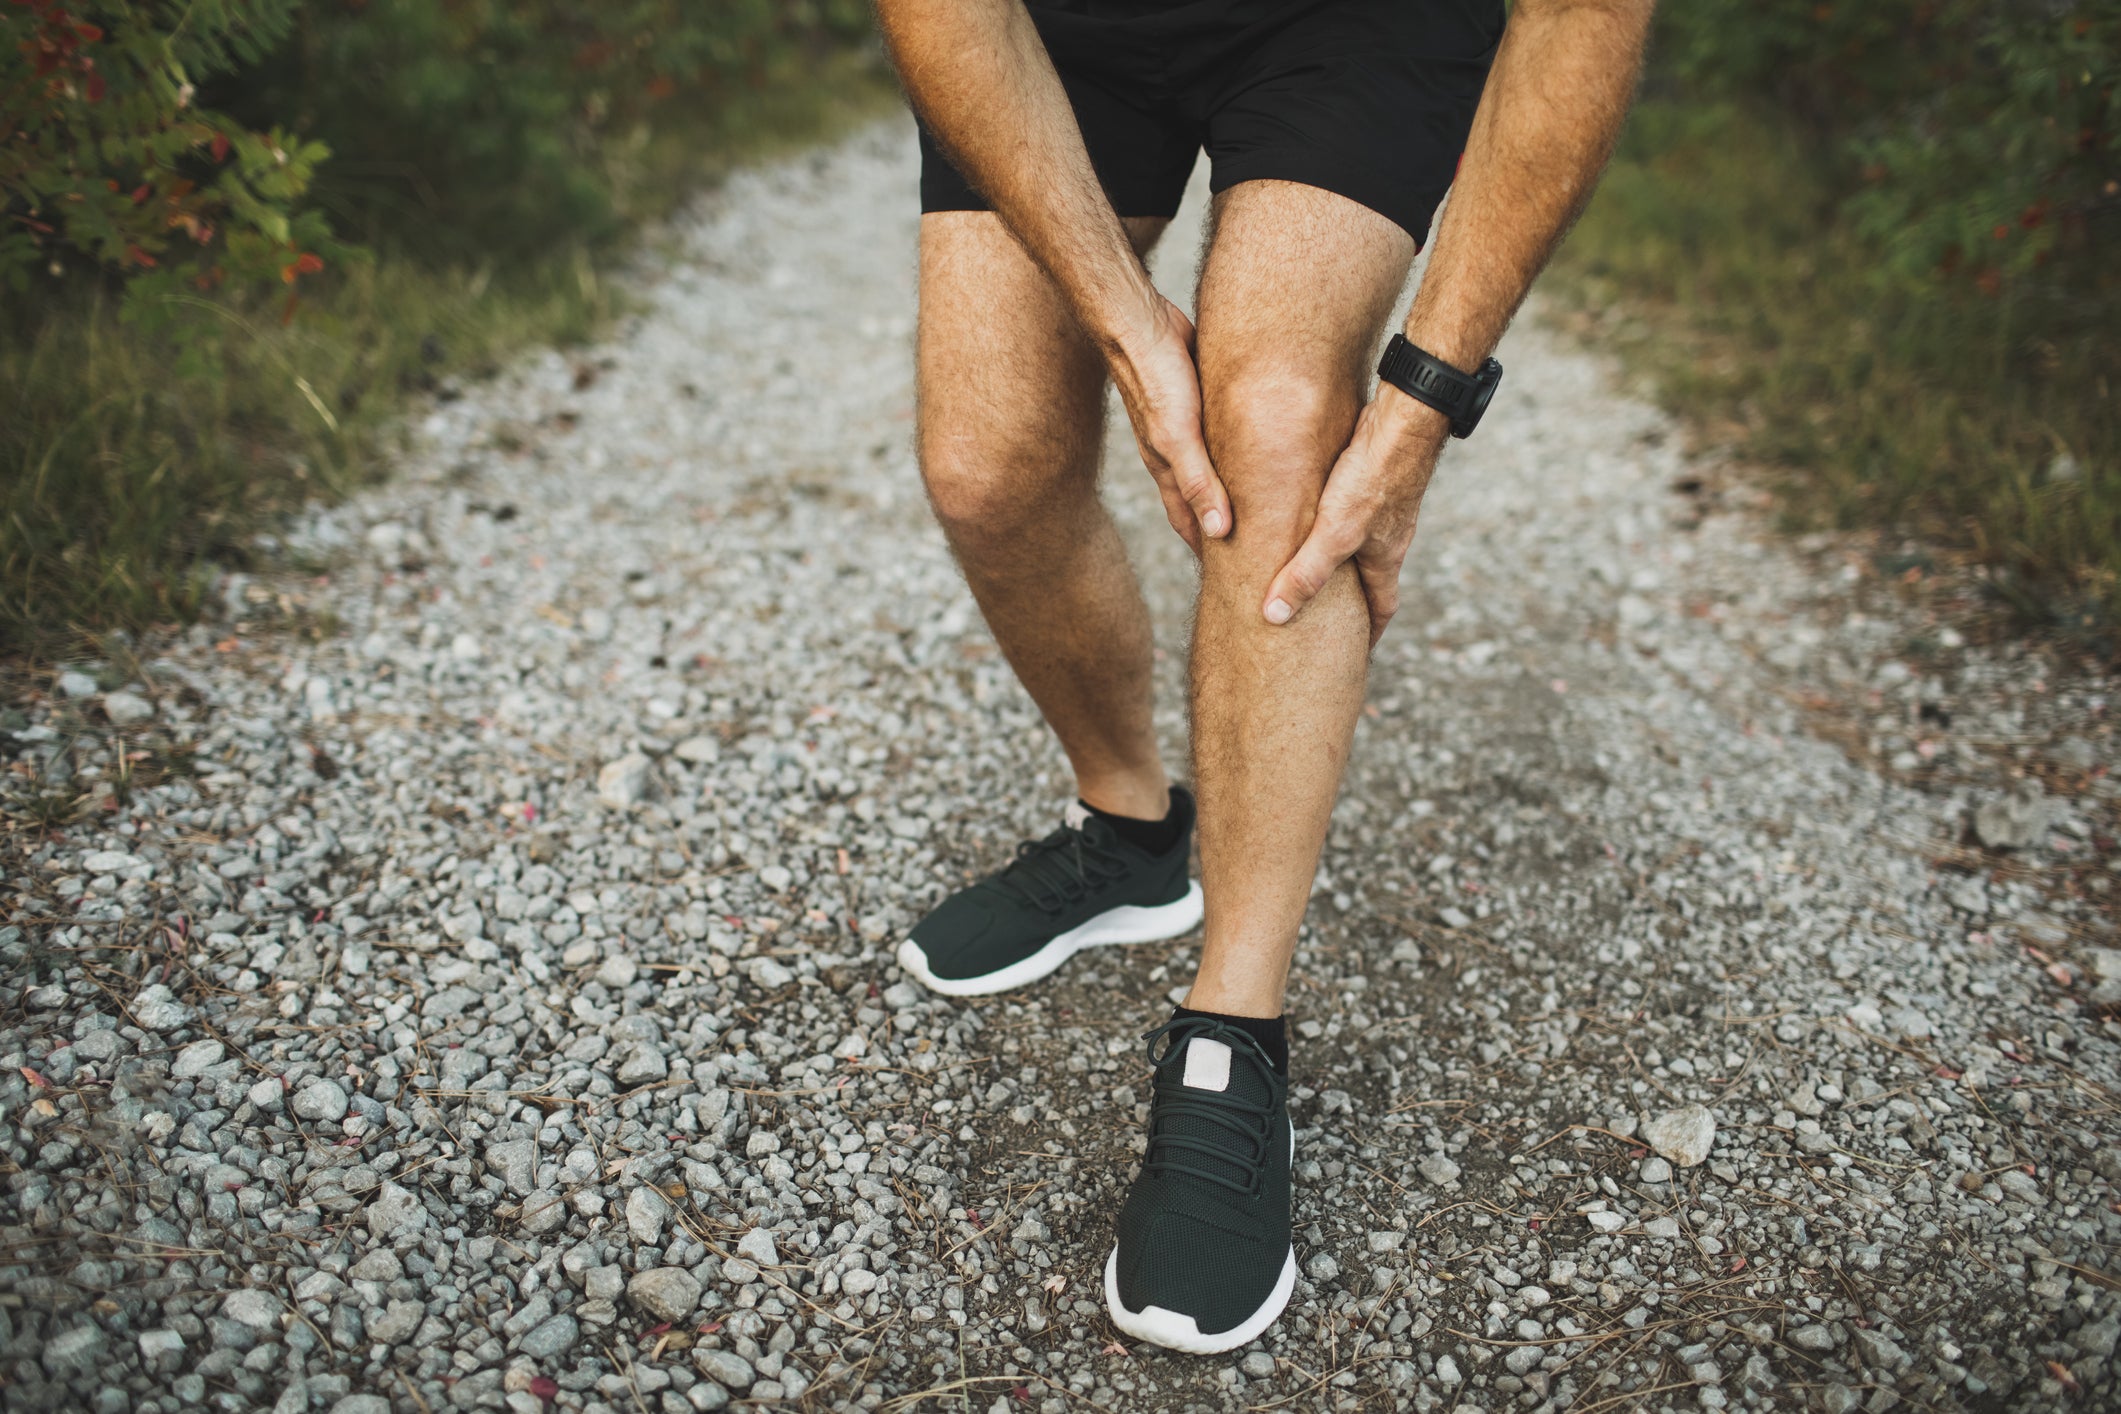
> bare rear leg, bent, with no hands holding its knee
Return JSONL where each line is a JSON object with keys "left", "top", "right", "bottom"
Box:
{"left": 916, "top": 212, "right": 1169, "bottom": 818}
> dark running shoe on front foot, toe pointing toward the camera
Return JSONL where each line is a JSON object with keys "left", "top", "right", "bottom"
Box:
{"left": 1105, "top": 1015, "right": 1296, "bottom": 1355}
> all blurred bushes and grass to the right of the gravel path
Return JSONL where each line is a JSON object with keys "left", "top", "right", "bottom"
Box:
{"left": 1559, "top": 0, "right": 2121, "bottom": 653}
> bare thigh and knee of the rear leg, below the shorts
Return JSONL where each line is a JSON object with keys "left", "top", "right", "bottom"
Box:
{"left": 914, "top": 212, "right": 1167, "bottom": 500}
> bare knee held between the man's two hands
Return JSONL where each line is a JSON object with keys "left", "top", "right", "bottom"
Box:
{"left": 1207, "top": 367, "right": 1357, "bottom": 566}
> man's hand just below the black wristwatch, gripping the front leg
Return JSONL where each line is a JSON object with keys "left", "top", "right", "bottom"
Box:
{"left": 1262, "top": 388, "right": 1451, "bottom": 649}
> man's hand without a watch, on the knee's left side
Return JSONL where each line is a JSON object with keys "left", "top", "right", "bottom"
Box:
{"left": 1107, "top": 295, "right": 1230, "bottom": 555}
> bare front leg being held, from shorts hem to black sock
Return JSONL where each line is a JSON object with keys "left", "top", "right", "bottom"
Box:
{"left": 1188, "top": 182, "right": 1415, "bottom": 1018}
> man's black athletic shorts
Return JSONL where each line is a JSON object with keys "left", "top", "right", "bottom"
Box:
{"left": 921, "top": 0, "right": 1504, "bottom": 246}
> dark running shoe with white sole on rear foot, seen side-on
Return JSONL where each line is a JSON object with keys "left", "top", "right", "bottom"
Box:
{"left": 899, "top": 786, "right": 1200, "bottom": 996}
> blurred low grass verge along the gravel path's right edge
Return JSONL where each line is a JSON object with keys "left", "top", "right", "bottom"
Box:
{"left": 1555, "top": 100, "right": 2121, "bottom": 632}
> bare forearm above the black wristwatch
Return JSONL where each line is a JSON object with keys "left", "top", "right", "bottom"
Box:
{"left": 1406, "top": 0, "right": 1650, "bottom": 381}
